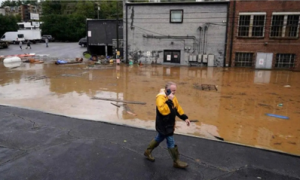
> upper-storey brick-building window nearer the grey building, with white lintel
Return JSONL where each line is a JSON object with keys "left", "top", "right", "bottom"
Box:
{"left": 238, "top": 13, "right": 266, "bottom": 37}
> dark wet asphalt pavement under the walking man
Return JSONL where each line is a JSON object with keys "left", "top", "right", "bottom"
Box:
{"left": 0, "top": 106, "right": 300, "bottom": 180}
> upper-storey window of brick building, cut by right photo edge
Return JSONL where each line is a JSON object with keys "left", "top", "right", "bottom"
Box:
{"left": 270, "top": 12, "right": 300, "bottom": 38}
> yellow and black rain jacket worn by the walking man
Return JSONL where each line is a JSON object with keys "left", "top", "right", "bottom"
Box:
{"left": 155, "top": 89, "right": 188, "bottom": 136}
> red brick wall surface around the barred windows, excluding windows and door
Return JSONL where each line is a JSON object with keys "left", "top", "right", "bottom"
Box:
{"left": 226, "top": 0, "right": 300, "bottom": 70}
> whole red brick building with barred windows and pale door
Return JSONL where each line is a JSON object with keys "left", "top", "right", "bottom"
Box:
{"left": 226, "top": 0, "right": 300, "bottom": 70}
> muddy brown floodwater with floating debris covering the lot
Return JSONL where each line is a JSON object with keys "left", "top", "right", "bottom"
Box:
{"left": 0, "top": 61, "right": 300, "bottom": 156}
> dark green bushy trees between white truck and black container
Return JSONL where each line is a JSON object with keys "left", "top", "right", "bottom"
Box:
{"left": 41, "top": 14, "right": 86, "bottom": 41}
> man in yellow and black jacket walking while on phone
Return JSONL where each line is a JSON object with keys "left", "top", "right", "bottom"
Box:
{"left": 144, "top": 82, "right": 190, "bottom": 168}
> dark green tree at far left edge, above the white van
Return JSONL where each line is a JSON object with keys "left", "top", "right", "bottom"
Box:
{"left": 0, "top": 14, "right": 18, "bottom": 36}
